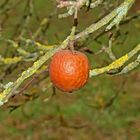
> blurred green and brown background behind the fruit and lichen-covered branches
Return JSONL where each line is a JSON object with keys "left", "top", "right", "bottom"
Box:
{"left": 0, "top": 0, "right": 140, "bottom": 140}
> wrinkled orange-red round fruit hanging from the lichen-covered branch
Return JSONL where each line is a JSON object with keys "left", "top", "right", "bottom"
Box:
{"left": 49, "top": 50, "right": 89, "bottom": 92}
